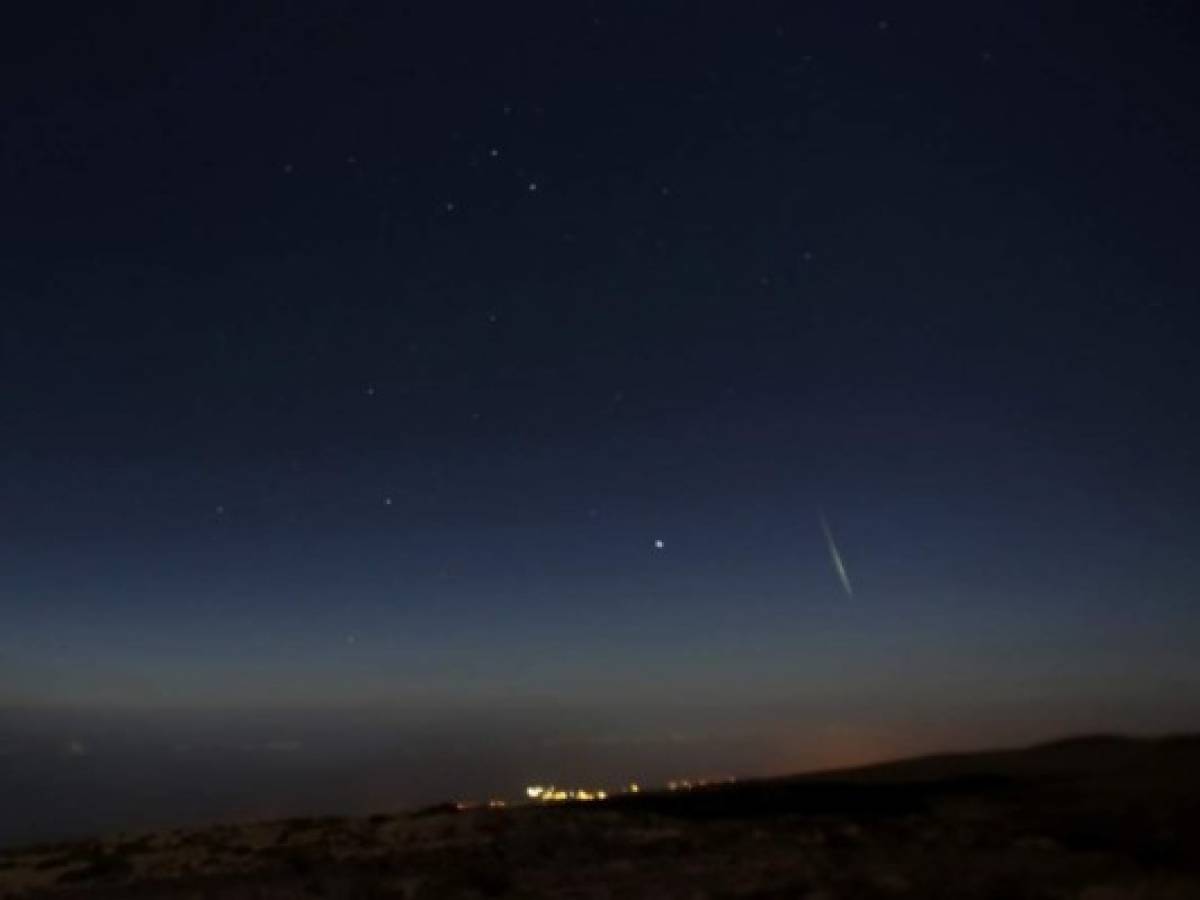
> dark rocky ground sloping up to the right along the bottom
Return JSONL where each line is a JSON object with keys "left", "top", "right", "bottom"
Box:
{"left": 0, "top": 737, "right": 1200, "bottom": 900}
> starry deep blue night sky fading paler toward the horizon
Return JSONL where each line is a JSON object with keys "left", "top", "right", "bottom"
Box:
{"left": 0, "top": 1, "right": 1200, "bottom": 830}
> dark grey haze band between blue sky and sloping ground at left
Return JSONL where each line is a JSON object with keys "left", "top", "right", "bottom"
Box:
{"left": 0, "top": 709, "right": 764, "bottom": 845}
